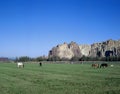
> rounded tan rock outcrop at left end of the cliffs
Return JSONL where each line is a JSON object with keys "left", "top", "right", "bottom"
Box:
{"left": 49, "top": 42, "right": 81, "bottom": 59}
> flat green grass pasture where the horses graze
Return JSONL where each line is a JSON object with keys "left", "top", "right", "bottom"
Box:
{"left": 0, "top": 63, "right": 120, "bottom": 94}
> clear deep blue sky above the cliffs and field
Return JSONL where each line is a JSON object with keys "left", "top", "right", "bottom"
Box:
{"left": 0, "top": 0, "right": 120, "bottom": 57}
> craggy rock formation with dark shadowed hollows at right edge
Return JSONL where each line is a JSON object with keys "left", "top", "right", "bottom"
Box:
{"left": 90, "top": 40, "right": 120, "bottom": 57}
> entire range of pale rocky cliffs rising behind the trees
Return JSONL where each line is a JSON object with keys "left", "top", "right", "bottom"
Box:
{"left": 49, "top": 40, "right": 120, "bottom": 59}
